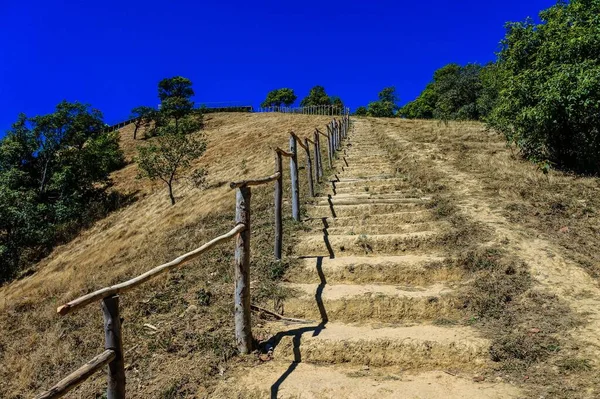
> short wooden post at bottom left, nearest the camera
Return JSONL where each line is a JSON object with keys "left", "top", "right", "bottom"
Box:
{"left": 101, "top": 295, "right": 125, "bottom": 399}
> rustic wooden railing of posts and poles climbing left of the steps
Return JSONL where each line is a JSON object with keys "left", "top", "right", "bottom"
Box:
{"left": 36, "top": 114, "right": 350, "bottom": 399}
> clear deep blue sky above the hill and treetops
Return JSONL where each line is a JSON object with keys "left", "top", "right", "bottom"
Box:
{"left": 0, "top": 0, "right": 555, "bottom": 135}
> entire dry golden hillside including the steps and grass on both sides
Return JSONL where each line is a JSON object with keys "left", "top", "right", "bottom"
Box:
{"left": 0, "top": 114, "right": 600, "bottom": 399}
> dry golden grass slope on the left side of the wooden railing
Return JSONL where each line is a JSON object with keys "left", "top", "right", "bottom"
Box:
{"left": 0, "top": 114, "right": 329, "bottom": 398}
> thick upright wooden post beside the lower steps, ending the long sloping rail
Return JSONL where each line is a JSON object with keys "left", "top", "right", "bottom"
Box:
{"left": 234, "top": 186, "right": 253, "bottom": 354}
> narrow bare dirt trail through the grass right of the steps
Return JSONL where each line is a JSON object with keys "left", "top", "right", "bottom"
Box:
{"left": 383, "top": 119, "right": 600, "bottom": 367}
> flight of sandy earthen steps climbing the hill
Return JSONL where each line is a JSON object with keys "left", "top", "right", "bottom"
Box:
{"left": 215, "top": 119, "right": 520, "bottom": 399}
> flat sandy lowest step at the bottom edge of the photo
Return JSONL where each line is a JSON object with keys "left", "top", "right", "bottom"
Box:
{"left": 215, "top": 366, "right": 522, "bottom": 399}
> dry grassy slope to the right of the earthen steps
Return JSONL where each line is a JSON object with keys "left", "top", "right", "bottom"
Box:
{"left": 366, "top": 120, "right": 600, "bottom": 398}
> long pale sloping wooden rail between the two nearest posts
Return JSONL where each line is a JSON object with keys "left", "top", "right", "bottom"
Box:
{"left": 56, "top": 224, "right": 246, "bottom": 316}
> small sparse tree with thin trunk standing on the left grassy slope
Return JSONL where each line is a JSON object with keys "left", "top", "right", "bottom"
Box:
{"left": 137, "top": 130, "right": 206, "bottom": 205}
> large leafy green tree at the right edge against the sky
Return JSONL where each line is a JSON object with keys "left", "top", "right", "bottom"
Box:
{"left": 489, "top": 0, "right": 600, "bottom": 173}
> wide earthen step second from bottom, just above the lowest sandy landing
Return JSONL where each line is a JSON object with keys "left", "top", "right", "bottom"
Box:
{"left": 266, "top": 323, "right": 490, "bottom": 371}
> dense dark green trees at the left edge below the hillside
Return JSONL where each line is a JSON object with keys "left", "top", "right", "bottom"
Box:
{"left": 0, "top": 101, "right": 123, "bottom": 281}
